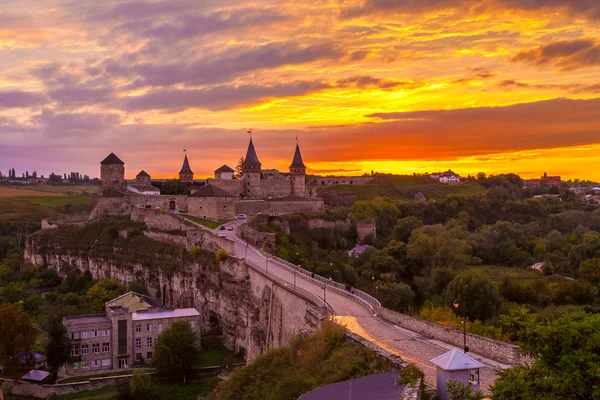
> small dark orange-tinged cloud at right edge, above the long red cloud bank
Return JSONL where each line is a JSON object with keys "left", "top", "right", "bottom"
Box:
{"left": 512, "top": 39, "right": 600, "bottom": 70}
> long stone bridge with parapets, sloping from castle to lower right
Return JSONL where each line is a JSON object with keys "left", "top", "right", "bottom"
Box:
{"left": 221, "top": 221, "right": 527, "bottom": 392}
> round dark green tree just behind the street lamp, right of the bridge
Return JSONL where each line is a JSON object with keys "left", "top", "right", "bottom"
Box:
{"left": 445, "top": 271, "right": 502, "bottom": 321}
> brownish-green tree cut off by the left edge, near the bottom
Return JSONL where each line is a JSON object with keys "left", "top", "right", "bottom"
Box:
{"left": 0, "top": 304, "right": 37, "bottom": 372}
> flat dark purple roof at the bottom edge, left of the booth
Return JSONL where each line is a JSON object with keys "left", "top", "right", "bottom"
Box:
{"left": 298, "top": 372, "right": 404, "bottom": 400}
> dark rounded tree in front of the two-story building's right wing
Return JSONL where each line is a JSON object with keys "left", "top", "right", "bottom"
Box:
{"left": 152, "top": 321, "right": 200, "bottom": 382}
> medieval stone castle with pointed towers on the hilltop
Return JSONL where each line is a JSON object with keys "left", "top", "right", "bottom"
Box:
{"left": 91, "top": 138, "right": 324, "bottom": 220}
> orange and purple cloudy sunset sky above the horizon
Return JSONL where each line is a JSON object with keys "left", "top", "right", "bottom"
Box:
{"left": 0, "top": 0, "right": 600, "bottom": 180}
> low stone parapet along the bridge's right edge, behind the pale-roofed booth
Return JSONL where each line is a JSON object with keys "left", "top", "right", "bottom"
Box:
{"left": 377, "top": 308, "right": 531, "bottom": 364}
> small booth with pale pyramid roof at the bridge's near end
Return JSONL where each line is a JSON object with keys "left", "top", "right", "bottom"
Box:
{"left": 430, "top": 349, "right": 484, "bottom": 400}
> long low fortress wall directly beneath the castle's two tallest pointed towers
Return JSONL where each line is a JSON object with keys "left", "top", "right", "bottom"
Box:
{"left": 235, "top": 199, "right": 325, "bottom": 215}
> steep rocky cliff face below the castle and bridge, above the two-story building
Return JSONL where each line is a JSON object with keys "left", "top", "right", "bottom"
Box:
{"left": 25, "top": 227, "right": 322, "bottom": 360}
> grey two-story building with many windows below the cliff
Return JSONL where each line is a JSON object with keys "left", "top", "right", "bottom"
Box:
{"left": 63, "top": 292, "right": 200, "bottom": 375}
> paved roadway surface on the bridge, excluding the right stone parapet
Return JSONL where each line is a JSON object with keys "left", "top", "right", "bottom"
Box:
{"left": 209, "top": 221, "right": 510, "bottom": 392}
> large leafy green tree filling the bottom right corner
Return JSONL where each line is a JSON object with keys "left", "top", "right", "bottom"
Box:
{"left": 491, "top": 312, "right": 600, "bottom": 400}
